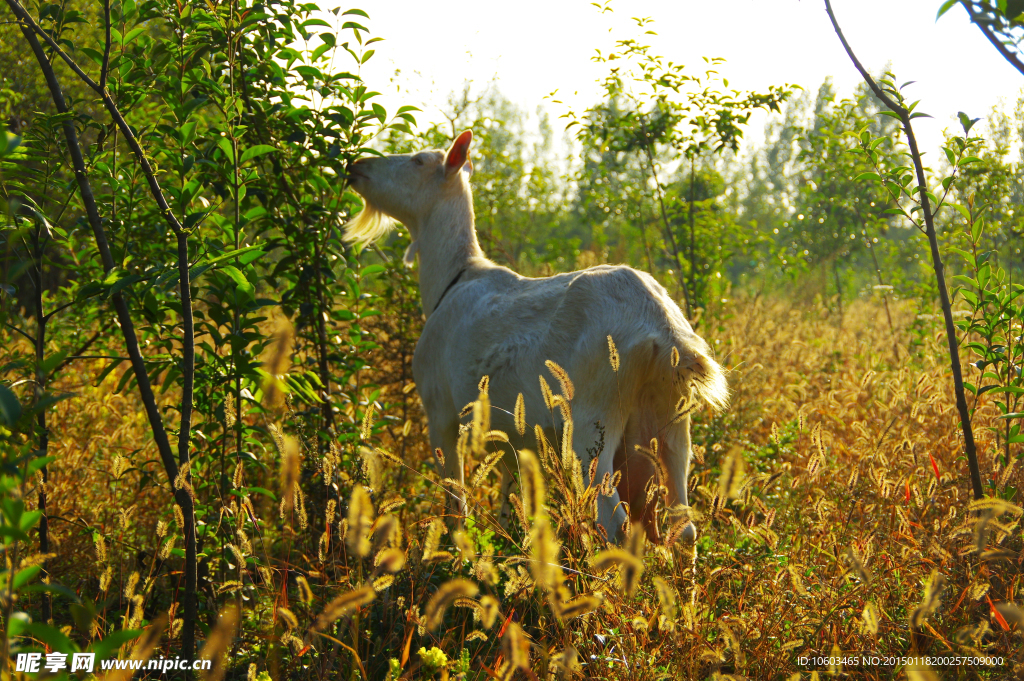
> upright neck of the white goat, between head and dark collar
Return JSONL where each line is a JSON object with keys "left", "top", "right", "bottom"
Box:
{"left": 416, "top": 173, "right": 493, "bottom": 317}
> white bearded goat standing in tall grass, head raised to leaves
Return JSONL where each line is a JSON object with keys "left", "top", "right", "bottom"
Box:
{"left": 345, "top": 130, "right": 728, "bottom": 541}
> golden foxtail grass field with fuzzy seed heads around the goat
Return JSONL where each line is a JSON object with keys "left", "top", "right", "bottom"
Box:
{"left": 22, "top": 299, "right": 1024, "bottom": 679}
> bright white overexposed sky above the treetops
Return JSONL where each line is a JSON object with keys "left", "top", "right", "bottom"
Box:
{"left": 339, "top": 0, "right": 1024, "bottom": 153}
